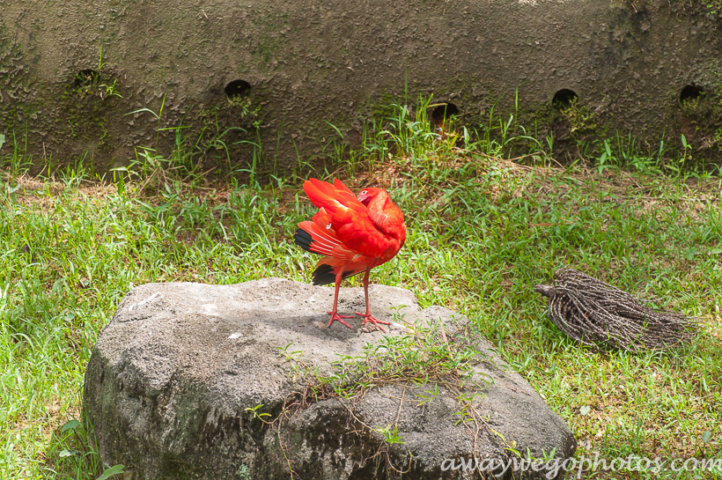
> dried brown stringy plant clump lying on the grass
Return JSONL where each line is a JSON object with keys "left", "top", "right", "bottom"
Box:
{"left": 534, "top": 268, "right": 697, "bottom": 351}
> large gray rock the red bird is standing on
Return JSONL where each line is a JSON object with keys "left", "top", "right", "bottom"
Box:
{"left": 84, "top": 279, "right": 575, "bottom": 480}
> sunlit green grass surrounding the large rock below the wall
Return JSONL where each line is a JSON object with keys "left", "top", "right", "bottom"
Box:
{"left": 0, "top": 100, "right": 722, "bottom": 479}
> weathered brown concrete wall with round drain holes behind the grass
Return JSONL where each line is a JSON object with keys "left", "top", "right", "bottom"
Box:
{"left": 0, "top": 0, "right": 722, "bottom": 170}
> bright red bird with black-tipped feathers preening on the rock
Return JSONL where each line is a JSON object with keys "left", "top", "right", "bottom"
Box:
{"left": 293, "top": 178, "right": 406, "bottom": 331}
